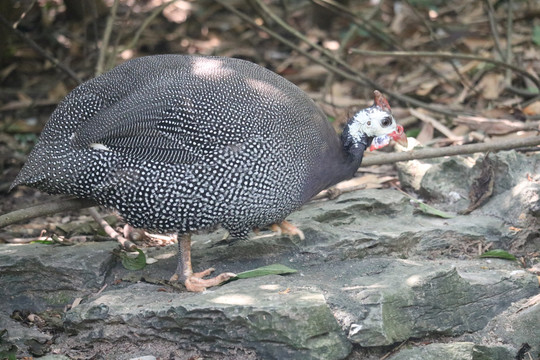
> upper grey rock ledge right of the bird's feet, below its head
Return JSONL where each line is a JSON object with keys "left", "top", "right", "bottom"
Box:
{"left": 290, "top": 190, "right": 515, "bottom": 260}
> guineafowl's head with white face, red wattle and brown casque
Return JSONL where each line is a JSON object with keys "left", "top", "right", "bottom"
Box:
{"left": 341, "top": 90, "right": 407, "bottom": 160}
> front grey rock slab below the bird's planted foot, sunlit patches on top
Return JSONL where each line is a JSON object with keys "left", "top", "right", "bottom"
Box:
{"left": 65, "top": 276, "right": 351, "bottom": 359}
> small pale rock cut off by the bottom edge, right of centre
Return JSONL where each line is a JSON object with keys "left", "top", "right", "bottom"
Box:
{"left": 388, "top": 342, "right": 513, "bottom": 360}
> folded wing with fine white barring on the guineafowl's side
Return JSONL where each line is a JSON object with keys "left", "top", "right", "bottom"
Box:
{"left": 72, "top": 90, "right": 223, "bottom": 164}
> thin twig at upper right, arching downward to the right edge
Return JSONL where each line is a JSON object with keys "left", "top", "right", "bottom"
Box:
{"left": 351, "top": 49, "right": 540, "bottom": 90}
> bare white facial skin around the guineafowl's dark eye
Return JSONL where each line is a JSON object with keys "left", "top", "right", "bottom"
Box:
{"left": 350, "top": 106, "right": 396, "bottom": 140}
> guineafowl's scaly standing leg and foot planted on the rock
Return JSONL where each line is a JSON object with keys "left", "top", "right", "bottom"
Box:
{"left": 171, "top": 234, "right": 236, "bottom": 292}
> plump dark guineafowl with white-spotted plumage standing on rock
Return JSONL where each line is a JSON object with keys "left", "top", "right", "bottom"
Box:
{"left": 11, "top": 54, "right": 407, "bottom": 292}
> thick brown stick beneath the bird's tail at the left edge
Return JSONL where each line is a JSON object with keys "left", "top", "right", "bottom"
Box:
{"left": 0, "top": 198, "right": 96, "bottom": 228}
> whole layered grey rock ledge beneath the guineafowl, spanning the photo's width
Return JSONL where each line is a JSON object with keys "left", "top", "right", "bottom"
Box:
{"left": 0, "top": 152, "right": 540, "bottom": 360}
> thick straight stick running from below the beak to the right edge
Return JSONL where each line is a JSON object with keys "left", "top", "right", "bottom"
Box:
{"left": 362, "top": 136, "right": 540, "bottom": 166}
